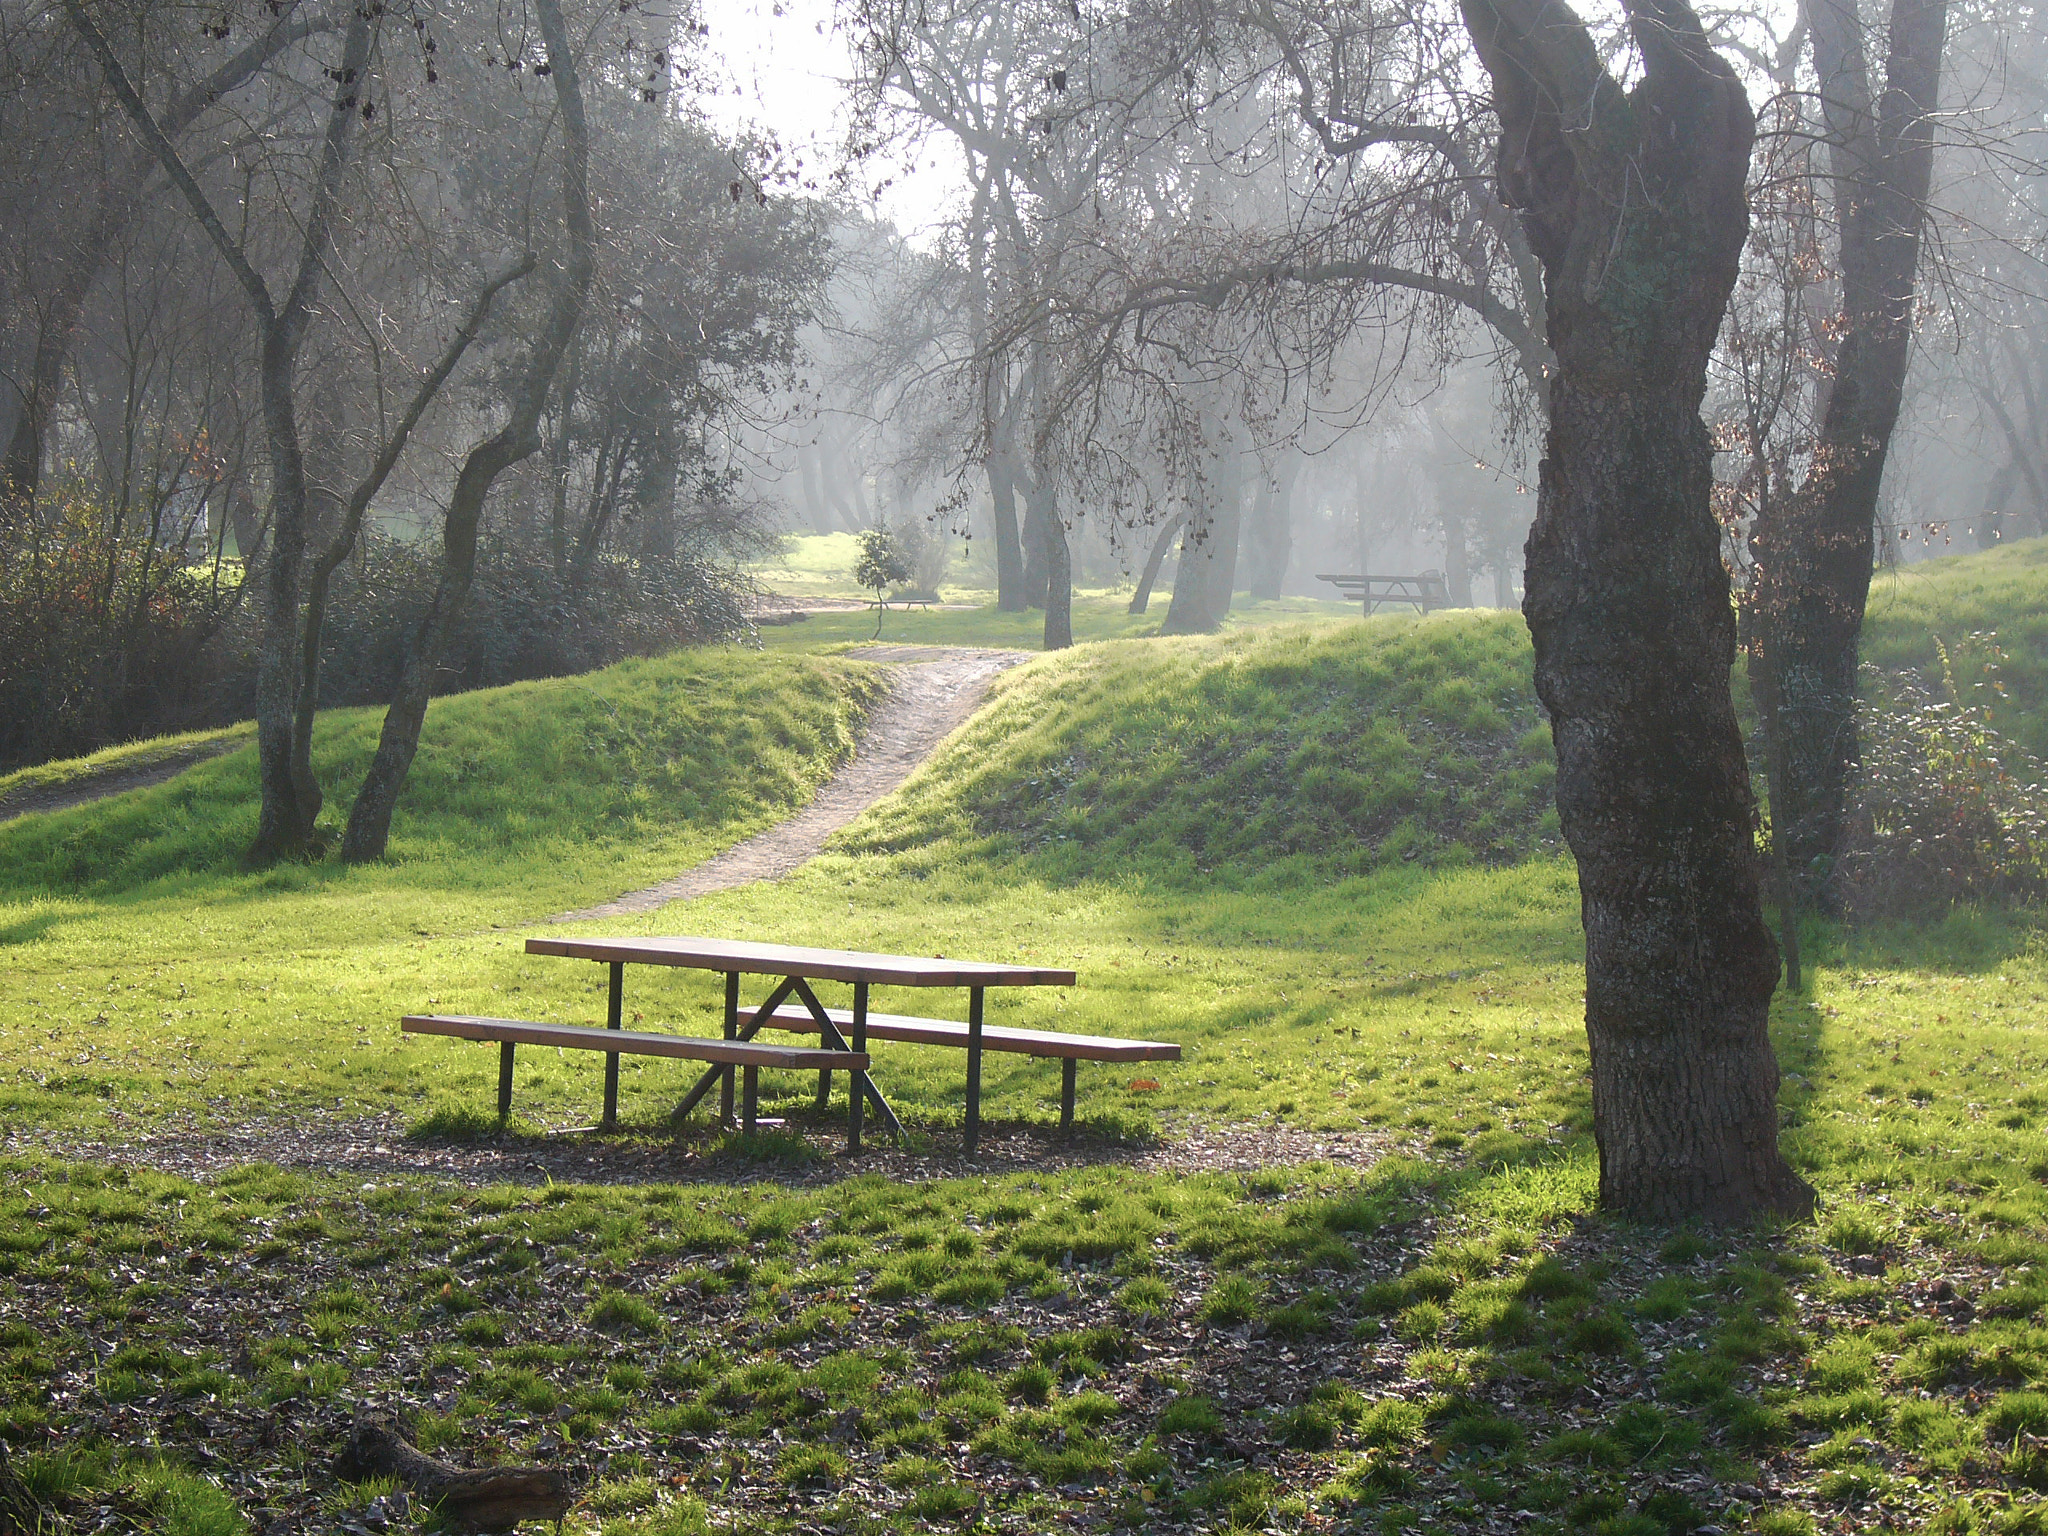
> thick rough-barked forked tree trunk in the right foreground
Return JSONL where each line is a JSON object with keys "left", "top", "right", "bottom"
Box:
{"left": 1464, "top": 0, "right": 1812, "bottom": 1221}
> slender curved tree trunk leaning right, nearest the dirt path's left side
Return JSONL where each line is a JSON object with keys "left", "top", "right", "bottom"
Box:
{"left": 342, "top": 0, "right": 594, "bottom": 864}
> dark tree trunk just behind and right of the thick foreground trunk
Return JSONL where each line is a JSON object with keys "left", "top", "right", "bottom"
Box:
{"left": 1751, "top": 0, "right": 1948, "bottom": 909}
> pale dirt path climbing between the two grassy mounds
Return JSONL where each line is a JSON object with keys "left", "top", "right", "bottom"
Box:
{"left": 549, "top": 645, "right": 1030, "bottom": 924}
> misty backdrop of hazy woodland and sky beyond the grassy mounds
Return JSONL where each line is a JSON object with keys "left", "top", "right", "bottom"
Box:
{"left": 0, "top": 0, "right": 2048, "bottom": 762}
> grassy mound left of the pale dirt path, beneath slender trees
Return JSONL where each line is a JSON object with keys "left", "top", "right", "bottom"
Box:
{"left": 0, "top": 651, "right": 877, "bottom": 895}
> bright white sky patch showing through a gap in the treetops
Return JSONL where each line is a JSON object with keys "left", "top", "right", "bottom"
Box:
{"left": 700, "top": 0, "right": 958, "bottom": 244}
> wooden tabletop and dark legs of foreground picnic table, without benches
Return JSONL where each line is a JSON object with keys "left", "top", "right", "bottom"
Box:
{"left": 526, "top": 938, "right": 1075, "bottom": 1153}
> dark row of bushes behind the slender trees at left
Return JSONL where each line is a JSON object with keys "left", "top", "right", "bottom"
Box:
{"left": 0, "top": 498, "right": 752, "bottom": 772}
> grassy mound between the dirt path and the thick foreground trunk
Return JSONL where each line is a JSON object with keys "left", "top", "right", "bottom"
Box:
{"left": 848, "top": 610, "right": 1556, "bottom": 885}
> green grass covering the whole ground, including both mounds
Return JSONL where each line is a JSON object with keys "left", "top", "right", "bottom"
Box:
{"left": 0, "top": 551, "right": 2048, "bottom": 1536}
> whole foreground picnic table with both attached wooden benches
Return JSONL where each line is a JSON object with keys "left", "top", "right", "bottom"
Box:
{"left": 403, "top": 938, "right": 1180, "bottom": 1153}
